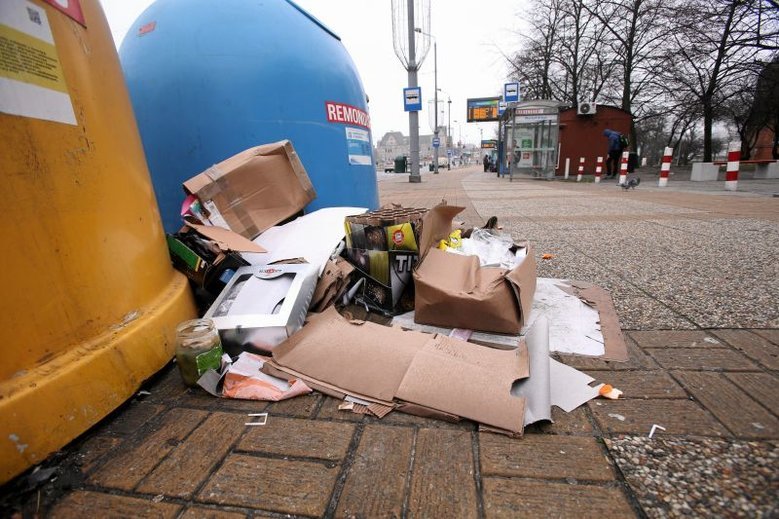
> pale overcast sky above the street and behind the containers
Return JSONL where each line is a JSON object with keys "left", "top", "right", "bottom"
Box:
{"left": 100, "top": 0, "right": 527, "bottom": 143}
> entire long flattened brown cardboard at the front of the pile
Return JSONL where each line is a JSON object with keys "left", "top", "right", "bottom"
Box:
{"left": 269, "top": 308, "right": 528, "bottom": 434}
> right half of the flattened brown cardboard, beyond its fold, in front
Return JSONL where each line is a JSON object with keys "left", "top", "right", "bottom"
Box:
{"left": 397, "top": 336, "right": 526, "bottom": 432}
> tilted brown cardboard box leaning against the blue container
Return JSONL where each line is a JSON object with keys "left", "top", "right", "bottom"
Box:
{"left": 184, "top": 140, "right": 316, "bottom": 239}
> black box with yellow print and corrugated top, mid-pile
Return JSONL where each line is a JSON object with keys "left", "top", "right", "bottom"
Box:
{"left": 344, "top": 206, "right": 427, "bottom": 315}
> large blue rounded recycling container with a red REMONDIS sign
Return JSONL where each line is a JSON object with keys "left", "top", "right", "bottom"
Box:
{"left": 119, "top": 0, "right": 378, "bottom": 232}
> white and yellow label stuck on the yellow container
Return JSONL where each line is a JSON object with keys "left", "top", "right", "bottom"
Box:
{"left": 0, "top": 0, "right": 76, "bottom": 125}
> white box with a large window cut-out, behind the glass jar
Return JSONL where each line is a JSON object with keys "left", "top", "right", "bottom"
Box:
{"left": 205, "top": 263, "right": 317, "bottom": 356}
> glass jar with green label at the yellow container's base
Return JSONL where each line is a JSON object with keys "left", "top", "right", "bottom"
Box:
{"left": 176, "top": 319, "right": 223, "bottom": 387}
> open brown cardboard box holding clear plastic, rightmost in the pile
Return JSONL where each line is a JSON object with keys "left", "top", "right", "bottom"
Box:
{"left": 414, "top": 204, "right": 536, "bottom": 334}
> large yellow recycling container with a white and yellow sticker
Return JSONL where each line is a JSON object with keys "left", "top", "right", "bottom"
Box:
{"left": 0, "top": 0, "right": 195, "bottom": 483}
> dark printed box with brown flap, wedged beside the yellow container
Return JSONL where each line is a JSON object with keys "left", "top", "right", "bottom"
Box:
{"left": 167, "top": 224, "right": 265, "bottom": 295}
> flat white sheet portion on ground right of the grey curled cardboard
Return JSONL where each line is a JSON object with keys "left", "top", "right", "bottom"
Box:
{"left": 526, "top": 278, "right": 605, "bottom": 356}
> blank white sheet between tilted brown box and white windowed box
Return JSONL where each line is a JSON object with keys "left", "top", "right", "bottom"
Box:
{"left": 242, "top": 207, "right": 366, "bottom": 276}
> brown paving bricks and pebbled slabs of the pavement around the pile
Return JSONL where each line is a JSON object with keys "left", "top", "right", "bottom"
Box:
{"left": 3, "top": 168, "right": 779, "bottom": 518}
